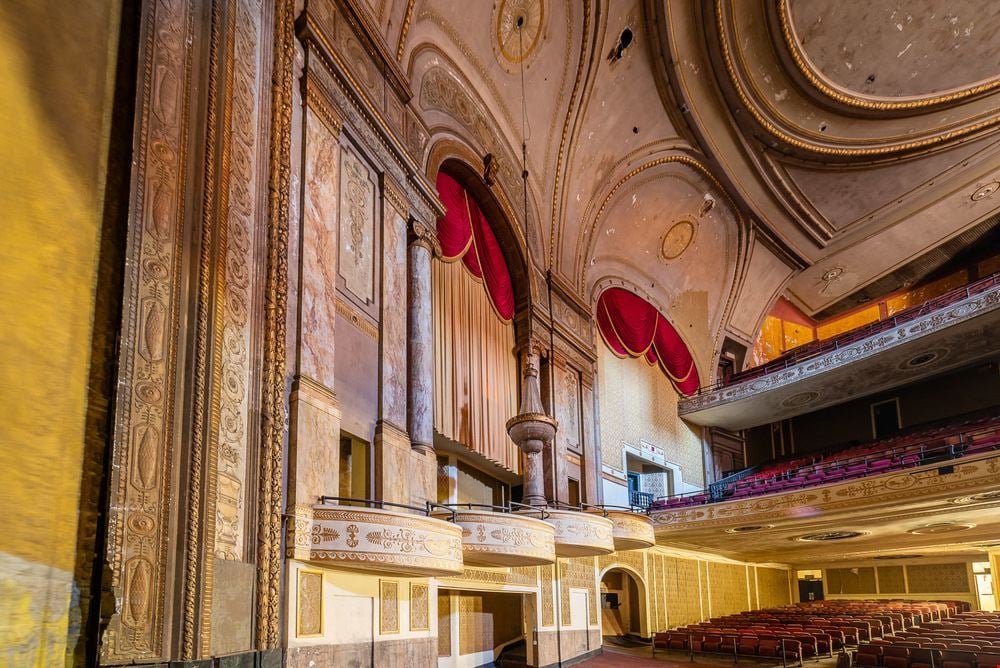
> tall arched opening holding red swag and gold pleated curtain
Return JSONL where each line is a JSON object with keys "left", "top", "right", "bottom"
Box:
{"left": 431, "top": 160, "right": 527, "bottom": 505}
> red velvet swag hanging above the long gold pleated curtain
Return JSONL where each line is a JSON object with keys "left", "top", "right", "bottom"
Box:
{"left": 437, "top": 172, "right": 514, "bottom": 322}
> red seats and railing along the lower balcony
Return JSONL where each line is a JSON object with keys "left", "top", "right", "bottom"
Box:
{"left": 650, "top": 406, "right": 1000, "bottom": 510}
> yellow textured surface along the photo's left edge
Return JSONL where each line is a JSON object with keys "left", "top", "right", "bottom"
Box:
{"left": 0, "top": 0, "right": 121, "bottom": 666}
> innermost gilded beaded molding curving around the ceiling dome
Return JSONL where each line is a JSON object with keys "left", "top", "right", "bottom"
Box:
{"left": 776, "top": 0, "right": 1000, "bottom": 111}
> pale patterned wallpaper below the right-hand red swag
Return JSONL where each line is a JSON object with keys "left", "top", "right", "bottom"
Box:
{"left": 598, "top": 345, "right": 705, "bottom": 487}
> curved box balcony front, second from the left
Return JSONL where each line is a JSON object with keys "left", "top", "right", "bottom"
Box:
{"left": 442, "top": 504, "right": 556, "bottom": 566}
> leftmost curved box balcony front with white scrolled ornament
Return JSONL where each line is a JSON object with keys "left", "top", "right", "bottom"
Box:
{"left": 295, "top": 497, "right": 463, "bottom": 576}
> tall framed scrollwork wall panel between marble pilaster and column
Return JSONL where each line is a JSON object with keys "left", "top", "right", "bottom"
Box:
{"left": 337, "top": 144, "right": 378, "bottom": 306}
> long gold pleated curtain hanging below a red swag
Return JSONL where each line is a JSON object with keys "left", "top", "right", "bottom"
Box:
{"left": 431, "top": 261, "right": 520, "bottom": 473}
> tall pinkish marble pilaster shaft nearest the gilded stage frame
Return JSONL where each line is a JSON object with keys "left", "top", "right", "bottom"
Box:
{"left": 293, "top": 103, "right": 340, "bottom": 389}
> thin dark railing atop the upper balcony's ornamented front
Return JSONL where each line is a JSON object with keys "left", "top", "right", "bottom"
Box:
{"left": 691, "top": 272, "right": 1000, "bottom": 396}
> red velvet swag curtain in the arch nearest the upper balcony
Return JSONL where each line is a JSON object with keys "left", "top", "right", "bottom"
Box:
{"left": 597, "top": 288, "right": 700, "bottom": 395}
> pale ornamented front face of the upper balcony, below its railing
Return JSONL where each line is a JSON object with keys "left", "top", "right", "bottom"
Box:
{"left": 677, "top": 286, "right": 1000, "bottom": 416}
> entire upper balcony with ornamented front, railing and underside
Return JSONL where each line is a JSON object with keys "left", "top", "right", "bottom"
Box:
{"left": 677, "top": 274, "right": 1000, "bottom": 430}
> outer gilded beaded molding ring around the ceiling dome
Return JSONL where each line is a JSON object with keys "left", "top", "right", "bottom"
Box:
{"left": 714, "top": 0, "right": 1000, "bottom": 157}
